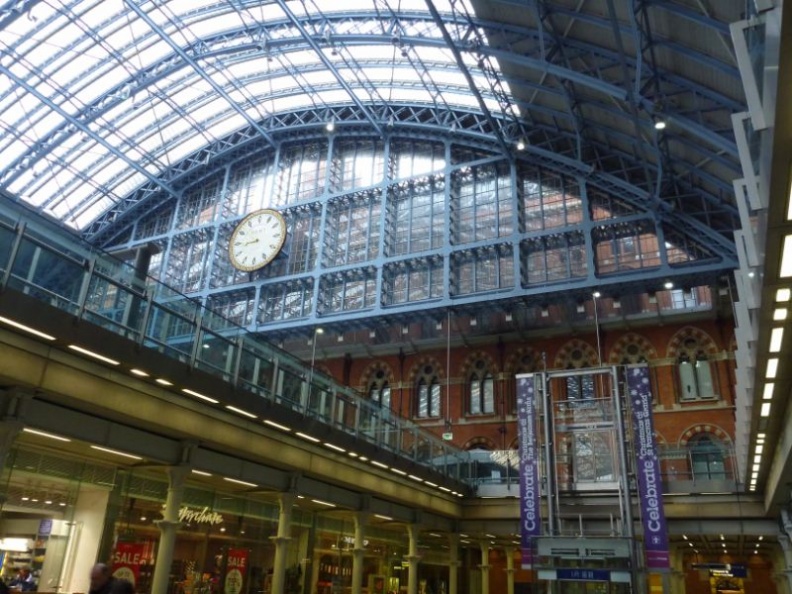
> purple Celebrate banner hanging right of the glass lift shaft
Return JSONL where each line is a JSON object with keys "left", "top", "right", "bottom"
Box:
{"left": 627, "top": 365, "right": 670, "bottom": 569}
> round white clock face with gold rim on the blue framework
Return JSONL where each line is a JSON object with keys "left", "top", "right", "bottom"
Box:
{"left": 228, "top": 208, "right": 286, "bottom": 272}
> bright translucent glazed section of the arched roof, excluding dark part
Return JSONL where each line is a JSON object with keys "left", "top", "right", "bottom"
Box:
{"left": 0, "top": 0, "right": 524, "bottom": 226}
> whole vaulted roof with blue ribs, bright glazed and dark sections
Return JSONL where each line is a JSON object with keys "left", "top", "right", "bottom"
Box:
{"left": 0, "top": 0, "right": 743, "bottom": 243}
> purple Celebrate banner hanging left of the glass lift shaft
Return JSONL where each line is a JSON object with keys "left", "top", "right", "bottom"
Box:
{"left": 517, "top": 374, "right": 542, "bottom": 569}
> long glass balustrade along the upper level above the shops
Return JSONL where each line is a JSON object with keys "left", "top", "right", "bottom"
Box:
{"left": 0, "top": 212, "right": 471, "bottom": 480}
